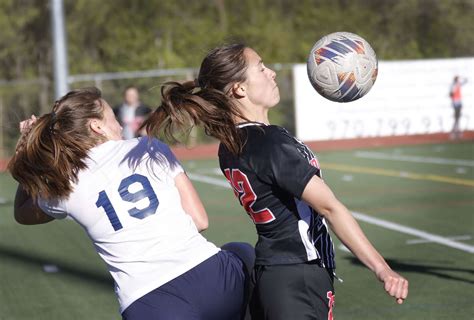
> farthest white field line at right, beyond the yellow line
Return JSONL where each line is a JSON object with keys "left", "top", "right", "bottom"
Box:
{"left": 355, "top": 151, "right": 474, "bottom": 167}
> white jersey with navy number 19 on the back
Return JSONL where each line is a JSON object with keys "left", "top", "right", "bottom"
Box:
{"left": 38, "top": 138, "right": 220, "bottom": 312}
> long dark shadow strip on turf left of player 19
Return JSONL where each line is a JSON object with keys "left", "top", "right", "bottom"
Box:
{"left": 0, "top": 245, "right": 114, "bottom": 290}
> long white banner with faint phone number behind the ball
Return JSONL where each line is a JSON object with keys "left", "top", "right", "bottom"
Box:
{"left": 293, "top": 58, "right": 474, "bottom": 140}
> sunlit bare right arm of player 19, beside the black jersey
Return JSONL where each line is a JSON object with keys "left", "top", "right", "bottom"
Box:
{"left": 174, "top": 172, "right": 209, "bottom": 232}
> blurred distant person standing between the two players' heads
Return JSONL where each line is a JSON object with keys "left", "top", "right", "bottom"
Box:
{"left": 114, "top": 86, "right": 151, "bottom": 139}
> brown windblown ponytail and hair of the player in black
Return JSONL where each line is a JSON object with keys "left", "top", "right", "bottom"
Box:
{"left": 143, "top": 44, "right": 247, "bottom": 154}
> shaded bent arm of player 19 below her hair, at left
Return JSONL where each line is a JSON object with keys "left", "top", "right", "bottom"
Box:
{"left": 13, "top": 185, "right": 54, "bottom": 225}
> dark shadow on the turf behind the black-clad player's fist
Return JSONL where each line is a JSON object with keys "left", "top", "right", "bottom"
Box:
{"left": 344, "top": 257, "right": 474, "bottom": 284}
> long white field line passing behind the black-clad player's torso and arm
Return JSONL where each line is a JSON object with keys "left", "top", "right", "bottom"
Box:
{"left": 188, "top": 173, "right": 474, "bottom": 253}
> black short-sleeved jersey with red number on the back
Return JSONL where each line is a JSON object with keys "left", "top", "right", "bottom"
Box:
{"left": 219, "top": 122, "right": 335, "bottom": 269}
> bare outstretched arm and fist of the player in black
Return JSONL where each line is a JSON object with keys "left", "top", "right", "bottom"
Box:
{"left": 302, "top": 176, "right": 408, "bottom": 304}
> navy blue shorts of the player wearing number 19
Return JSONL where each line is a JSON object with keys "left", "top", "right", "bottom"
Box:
{"left": 122, "top": 250, "right": 246, "bottom": 320}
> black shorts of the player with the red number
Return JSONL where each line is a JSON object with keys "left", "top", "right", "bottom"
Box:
{"left": 251, "top": 263, "right": 335, "bottom": 320}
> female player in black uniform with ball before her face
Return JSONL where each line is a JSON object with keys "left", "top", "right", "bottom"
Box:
{"left": 146, "top": 44, "right": 408, "bottom": 320}
